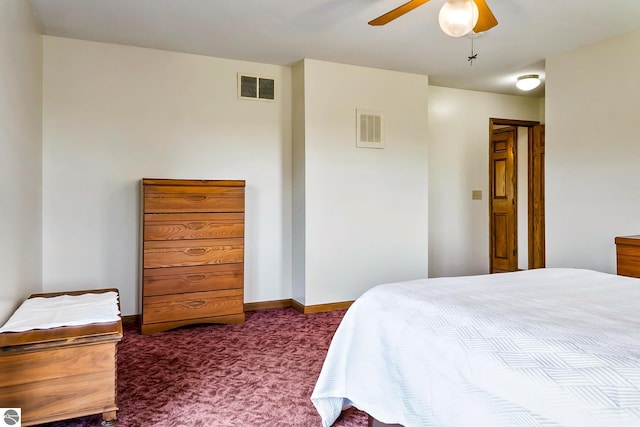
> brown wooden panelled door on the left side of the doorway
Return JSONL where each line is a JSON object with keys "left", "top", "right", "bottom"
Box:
{"left": 489, "top": 126, "right": 518, "bottom": 273}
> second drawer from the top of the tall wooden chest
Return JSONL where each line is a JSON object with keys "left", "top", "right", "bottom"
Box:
{"left": 144, "top": 213, "right": 244, "bottom": 240}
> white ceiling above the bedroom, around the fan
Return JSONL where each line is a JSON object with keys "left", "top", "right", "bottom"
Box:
{"left": 30, "top": 0, "right": 640, "bottom": 97}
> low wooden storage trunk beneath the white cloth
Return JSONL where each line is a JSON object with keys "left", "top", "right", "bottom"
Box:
{"left": 0, "top": 289, "right": 122, "bottom": 426}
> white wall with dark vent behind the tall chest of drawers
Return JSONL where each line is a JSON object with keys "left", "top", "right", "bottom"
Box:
{"left": 43, "top": 36, "right": 291, "bottom": 315}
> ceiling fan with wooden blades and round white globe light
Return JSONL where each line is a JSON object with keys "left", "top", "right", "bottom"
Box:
{"left": 369, "top": 0, "right": 498, "bottom": 37}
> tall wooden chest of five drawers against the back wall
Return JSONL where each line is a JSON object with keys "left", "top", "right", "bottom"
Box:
{"left": 141, "top": 179, "right": 245, "bottom": 334}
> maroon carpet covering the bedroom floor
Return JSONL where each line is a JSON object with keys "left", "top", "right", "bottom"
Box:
{"left": 40, "top": 308, "right": 367, "bottom": 427}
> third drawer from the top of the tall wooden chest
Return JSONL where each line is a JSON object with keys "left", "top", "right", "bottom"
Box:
{"left": 143, "top": 239, "right": 244, "bottom": 268}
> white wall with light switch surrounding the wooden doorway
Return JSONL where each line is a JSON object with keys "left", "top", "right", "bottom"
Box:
{"left": 429, "top": 86, "right": 542, "bottom": 277}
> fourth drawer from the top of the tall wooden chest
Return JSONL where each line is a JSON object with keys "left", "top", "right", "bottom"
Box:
{"left": 143, "top": 263, "right": 244, "bottom": 296}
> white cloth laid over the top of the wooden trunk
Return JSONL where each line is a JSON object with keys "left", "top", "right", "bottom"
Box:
{"left": 0, "top": 291, "right": 120, "bottom": 332}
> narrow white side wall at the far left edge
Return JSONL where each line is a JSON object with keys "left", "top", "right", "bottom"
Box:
{"left": 0, "top": 0, "right": 42, "bottom": 324}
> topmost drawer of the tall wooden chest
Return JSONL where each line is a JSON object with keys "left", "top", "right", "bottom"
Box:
{"left": 144, "top": 185, "right": 244, "bottom": 213}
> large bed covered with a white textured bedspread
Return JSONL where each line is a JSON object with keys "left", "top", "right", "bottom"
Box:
{"left": 311, "top": 268, "right": 640, "bottom": 427}
